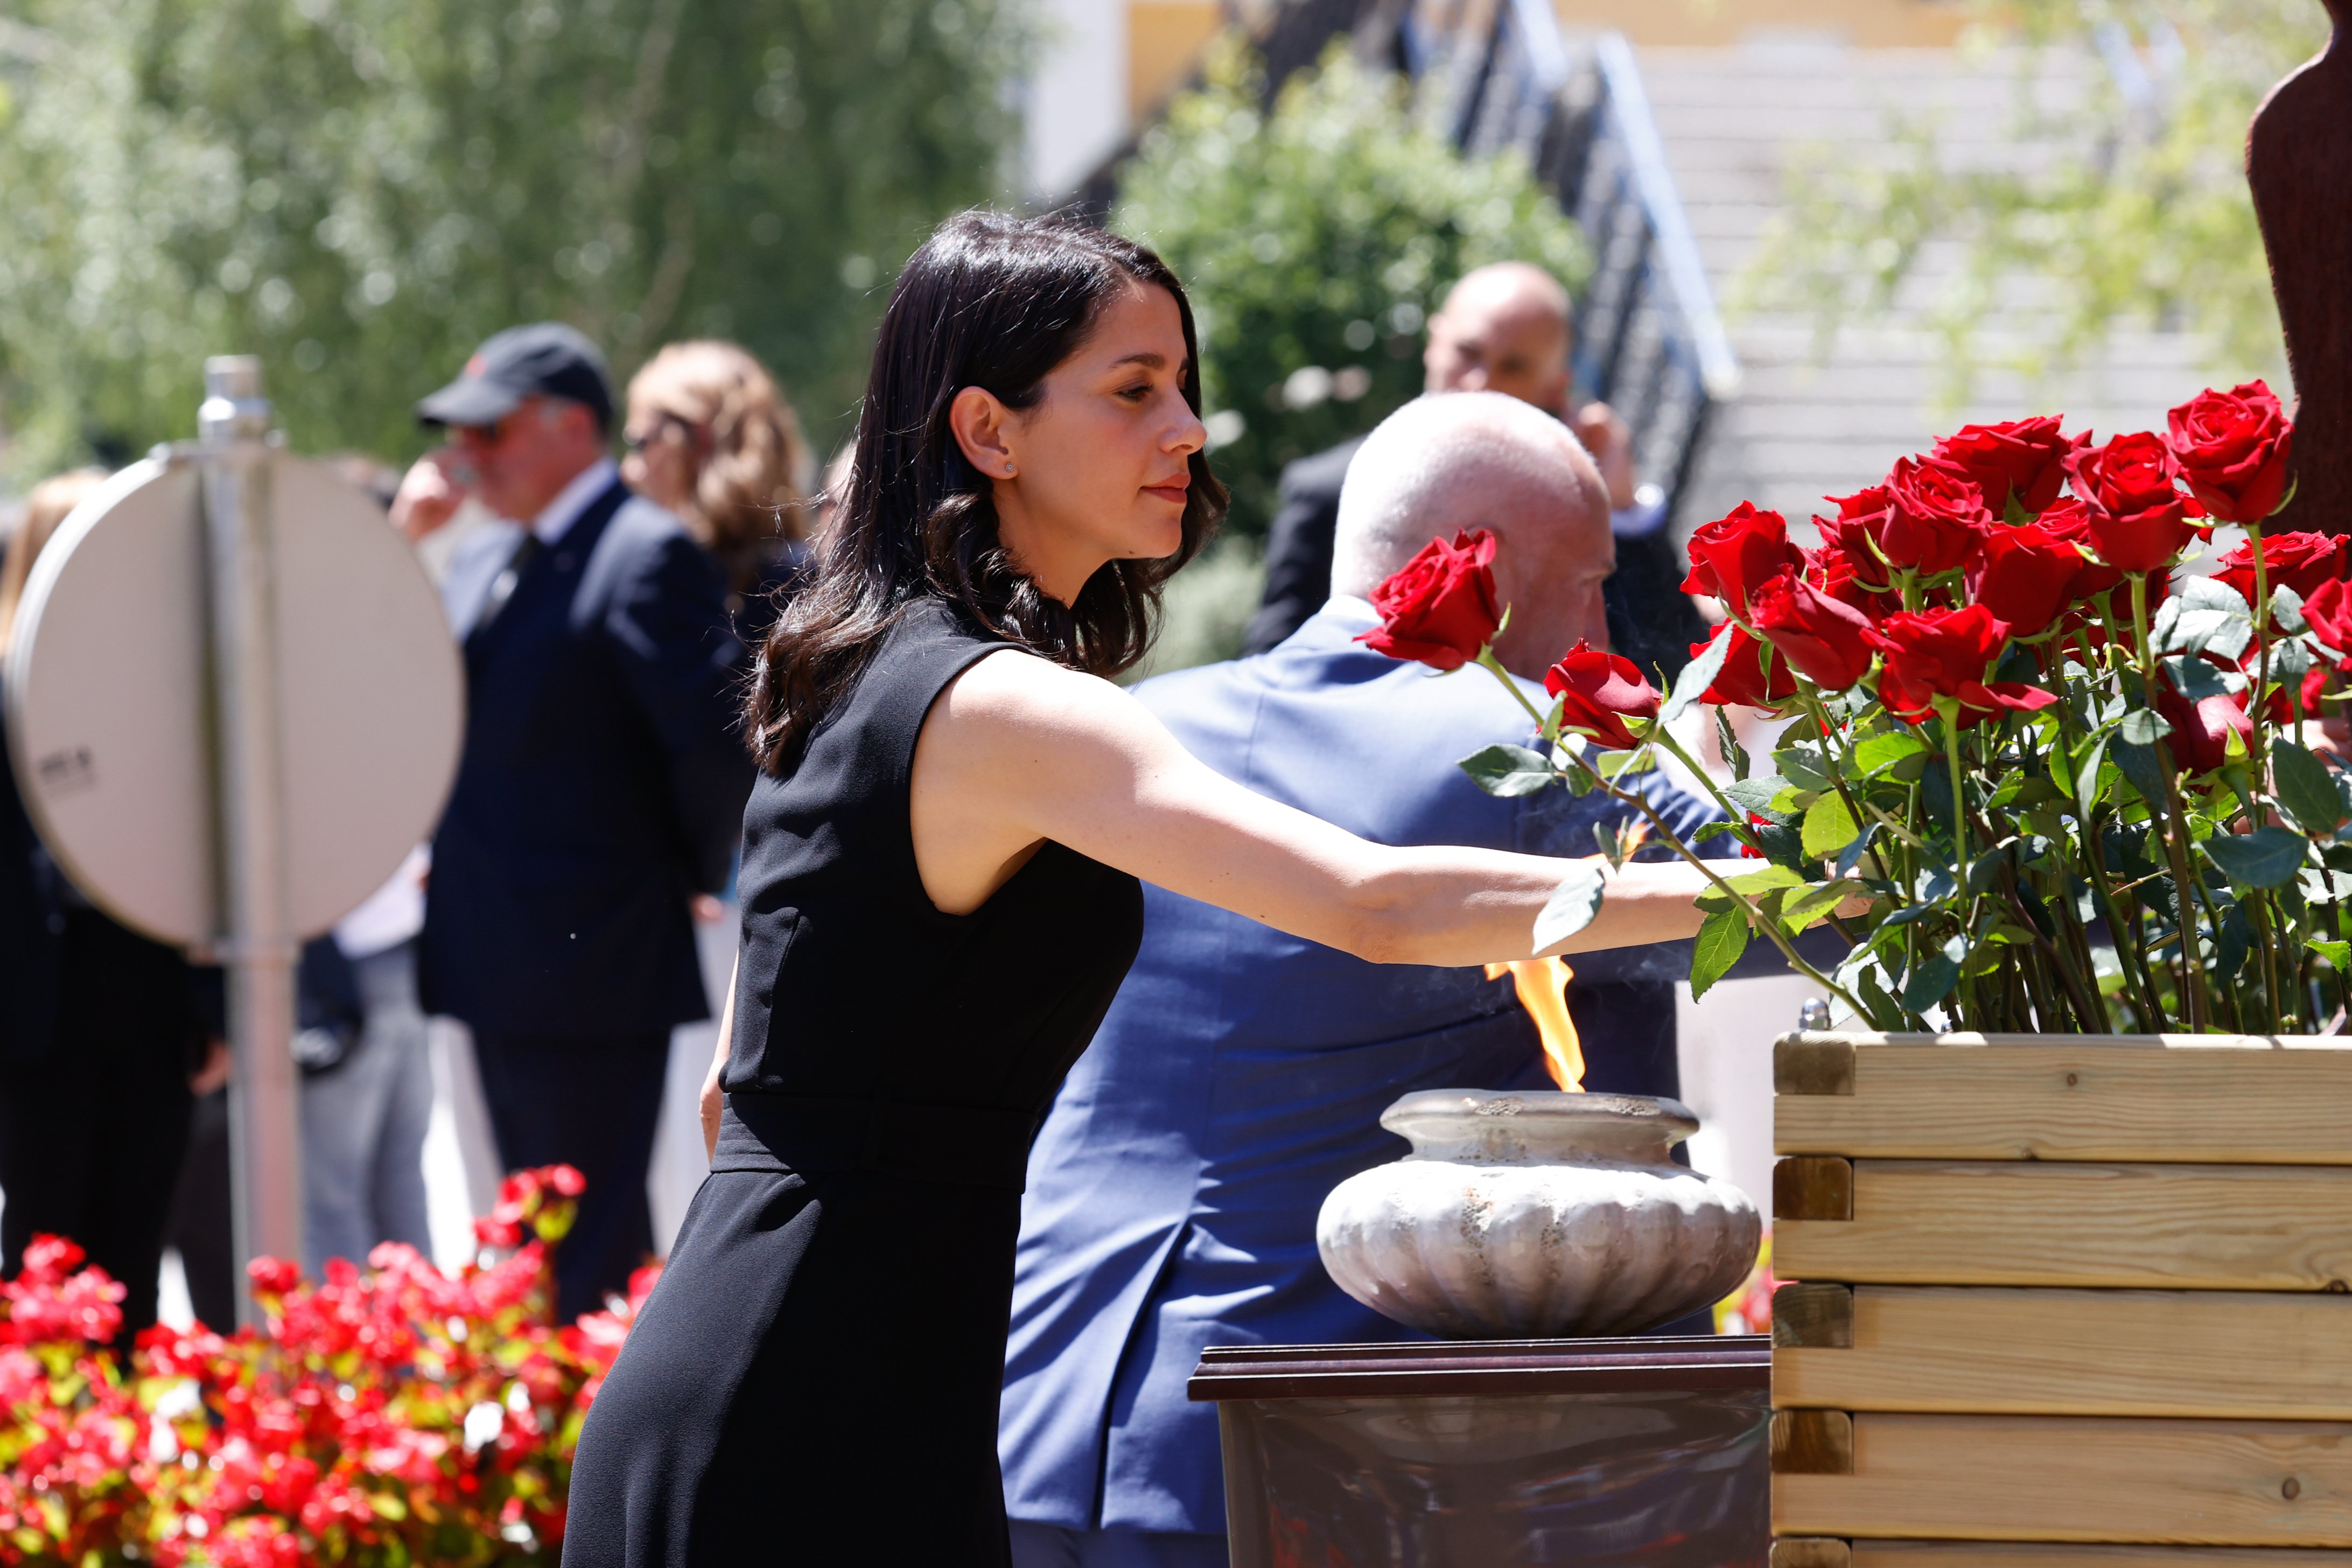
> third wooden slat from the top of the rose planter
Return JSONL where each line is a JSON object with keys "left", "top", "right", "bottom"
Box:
{"left": 1771, "top": 1286, "right": 2352, "bottom": 1422}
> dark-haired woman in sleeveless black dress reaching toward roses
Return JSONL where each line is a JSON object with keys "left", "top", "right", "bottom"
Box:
{"left": 564, "top": 214, "right": 1698, "bottom": 1568}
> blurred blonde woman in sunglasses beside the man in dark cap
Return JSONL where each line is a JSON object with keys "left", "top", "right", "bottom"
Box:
{"left": 621, "top": 339, "right": 809, "bottom": 647}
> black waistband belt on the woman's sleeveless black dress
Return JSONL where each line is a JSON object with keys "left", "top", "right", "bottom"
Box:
{"left": 710, "top": 1093, "right": 1037, "bottom": 1192}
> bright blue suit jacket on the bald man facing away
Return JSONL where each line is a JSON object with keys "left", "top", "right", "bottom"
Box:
{"left": 999, "top": 599, "right": 1726, "bottom": 1530}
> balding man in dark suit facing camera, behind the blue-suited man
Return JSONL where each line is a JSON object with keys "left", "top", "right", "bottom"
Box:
{"left": 1244, "top": 261, "right": 1707, "bottom": 680}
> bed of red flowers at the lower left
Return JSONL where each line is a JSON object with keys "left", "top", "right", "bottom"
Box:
{"left": 0, "top": 1166, "right": 659, "bottom": 1568}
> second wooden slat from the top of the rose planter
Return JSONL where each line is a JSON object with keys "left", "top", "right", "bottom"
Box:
{"left": 1773, "top": 1161, "right": 2352, "bottom": 1291}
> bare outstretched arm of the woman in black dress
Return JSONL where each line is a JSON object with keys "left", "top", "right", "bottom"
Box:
{"left": 913, "top": 651, "right": 1705, "bottom": 966}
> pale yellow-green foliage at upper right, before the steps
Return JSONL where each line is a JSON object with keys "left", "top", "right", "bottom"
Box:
{"left": 1743, "top": 0, "right": 2328, "bottom": 397}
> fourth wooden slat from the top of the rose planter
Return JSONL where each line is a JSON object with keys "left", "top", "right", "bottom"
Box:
{"left": 1771, "top": 1415, "right": 2352, "bottom": 1547}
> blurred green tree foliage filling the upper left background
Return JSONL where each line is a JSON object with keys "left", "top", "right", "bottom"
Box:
{"left": 0, "top": 0, "right": 1018, "bottom": 477}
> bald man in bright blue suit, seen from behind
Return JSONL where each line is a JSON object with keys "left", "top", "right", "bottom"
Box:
{"left": 999, "top": 393, "right": 1714, "bottom": 1568}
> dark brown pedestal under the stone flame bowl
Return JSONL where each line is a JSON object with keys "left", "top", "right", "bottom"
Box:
{"left": 1190, "top": 1335, "right": 1771, "bottom": 1568}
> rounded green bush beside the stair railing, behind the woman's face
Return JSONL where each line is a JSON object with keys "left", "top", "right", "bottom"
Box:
{"left": 1112, "top": 43, "right": 1585, "bottom": 534}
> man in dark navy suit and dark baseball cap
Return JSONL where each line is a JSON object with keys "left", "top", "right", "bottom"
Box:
{"left": 395, "top": 322, "right": 753, "bottom": 1317}
